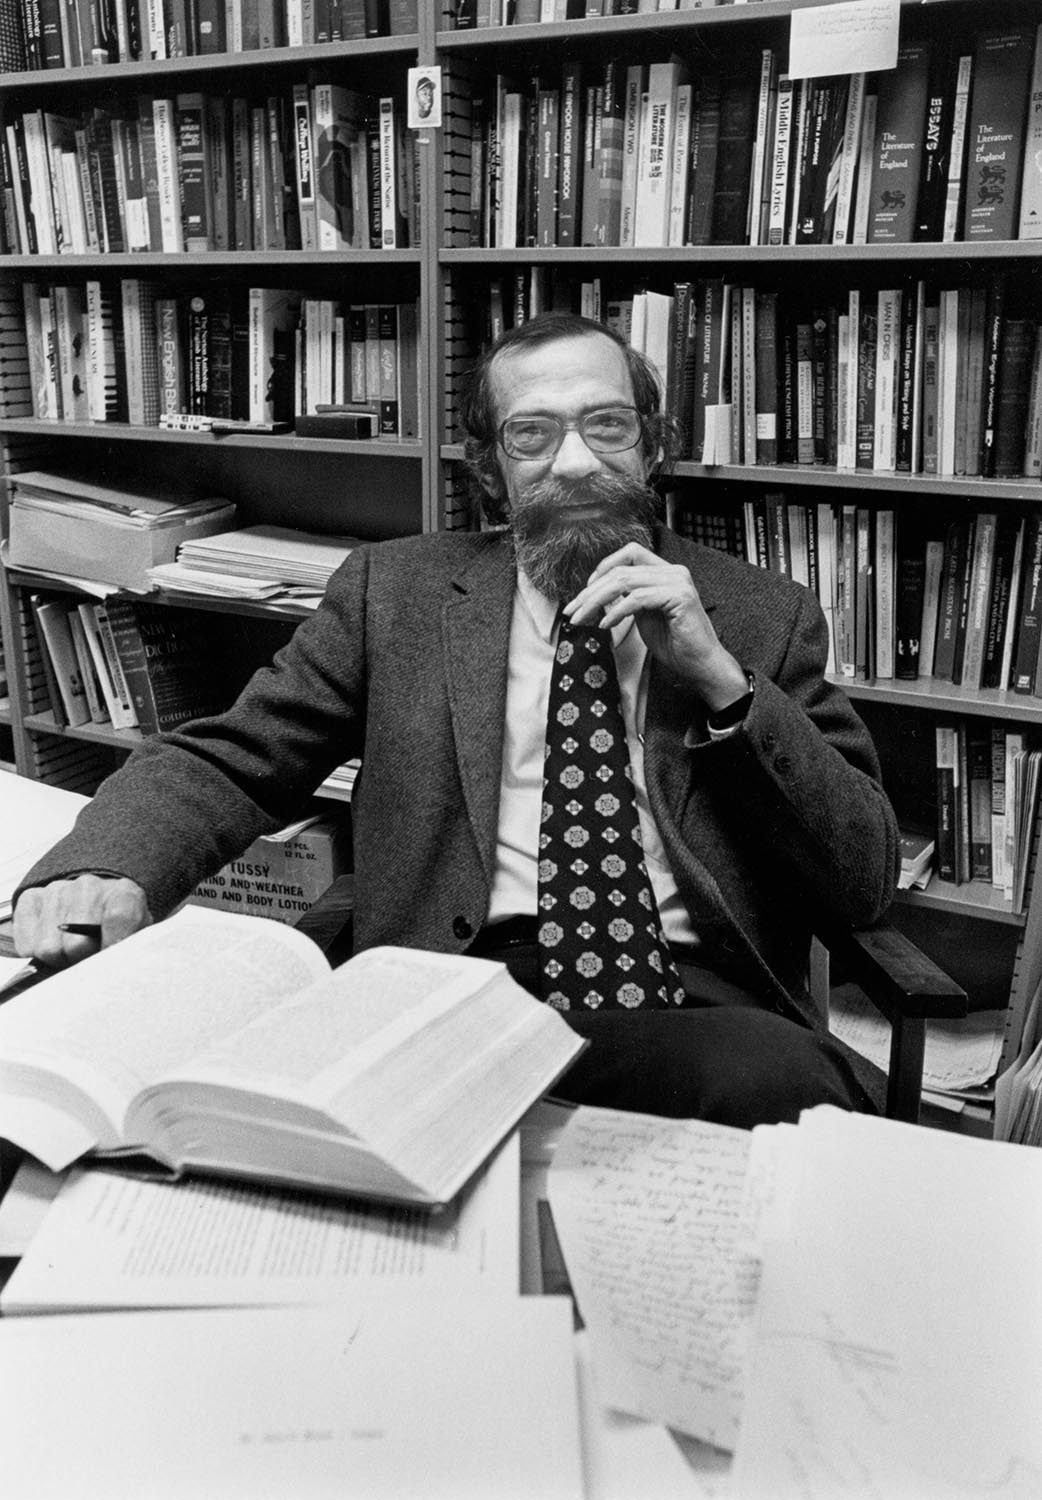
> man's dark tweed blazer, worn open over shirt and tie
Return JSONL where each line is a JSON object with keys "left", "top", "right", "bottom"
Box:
{"left": 18, "top": 531, "right": 898, "bottom": 1020}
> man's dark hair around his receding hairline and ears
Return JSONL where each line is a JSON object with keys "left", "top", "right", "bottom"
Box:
{"left": 460, "top": 312, "right": 678, "bottom": 522}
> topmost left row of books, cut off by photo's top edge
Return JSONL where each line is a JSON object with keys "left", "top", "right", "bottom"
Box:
{"left": 0, "top": 0, "right": 417, "bottom": 72}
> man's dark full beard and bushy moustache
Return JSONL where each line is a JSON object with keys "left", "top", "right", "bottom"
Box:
{"left": 510, "top": 474, "right": 658, "bottom": 605}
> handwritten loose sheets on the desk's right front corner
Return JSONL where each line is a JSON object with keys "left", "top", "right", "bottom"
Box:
{"left": 549, "top": 1106, "right": 1042, "bottom": 1500}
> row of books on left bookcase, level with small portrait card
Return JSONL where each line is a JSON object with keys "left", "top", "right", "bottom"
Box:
{"left": 0, "top": 83, "right": 420, "bottom": 255}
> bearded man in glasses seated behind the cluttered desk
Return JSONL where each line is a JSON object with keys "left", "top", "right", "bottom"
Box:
{"left": 15, "top": 314, "right": 897, "bottom": 1125}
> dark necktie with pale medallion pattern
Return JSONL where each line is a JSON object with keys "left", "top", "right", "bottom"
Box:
{"left": 538, "top": 620, "right": 684, "bottom": 1010}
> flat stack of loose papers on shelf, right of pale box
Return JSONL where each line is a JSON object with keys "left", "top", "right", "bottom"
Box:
{"left": 148, "top": 527, "right": 357, "bottom": 605}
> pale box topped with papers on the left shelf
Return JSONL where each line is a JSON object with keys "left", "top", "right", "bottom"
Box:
{"left": 9, "top": 471, "right": 235, "bottom": 593}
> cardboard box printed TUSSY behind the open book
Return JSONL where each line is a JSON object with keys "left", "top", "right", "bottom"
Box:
{"left": 190, "top": 818, "right": 351, "bottom": 923}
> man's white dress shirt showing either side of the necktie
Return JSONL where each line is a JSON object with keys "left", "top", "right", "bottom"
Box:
{"left": 487, "top": 573, "right": 697, "bottom": 947}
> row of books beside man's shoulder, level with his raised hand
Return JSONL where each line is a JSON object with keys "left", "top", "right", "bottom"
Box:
{"left": 672, "top": 492, "right": 1042, "bottom": 699}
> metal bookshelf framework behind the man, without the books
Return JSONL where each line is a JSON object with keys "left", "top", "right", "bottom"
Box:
{"left": 0, "top": 0, "right": 1042, "bottom": 1122}
